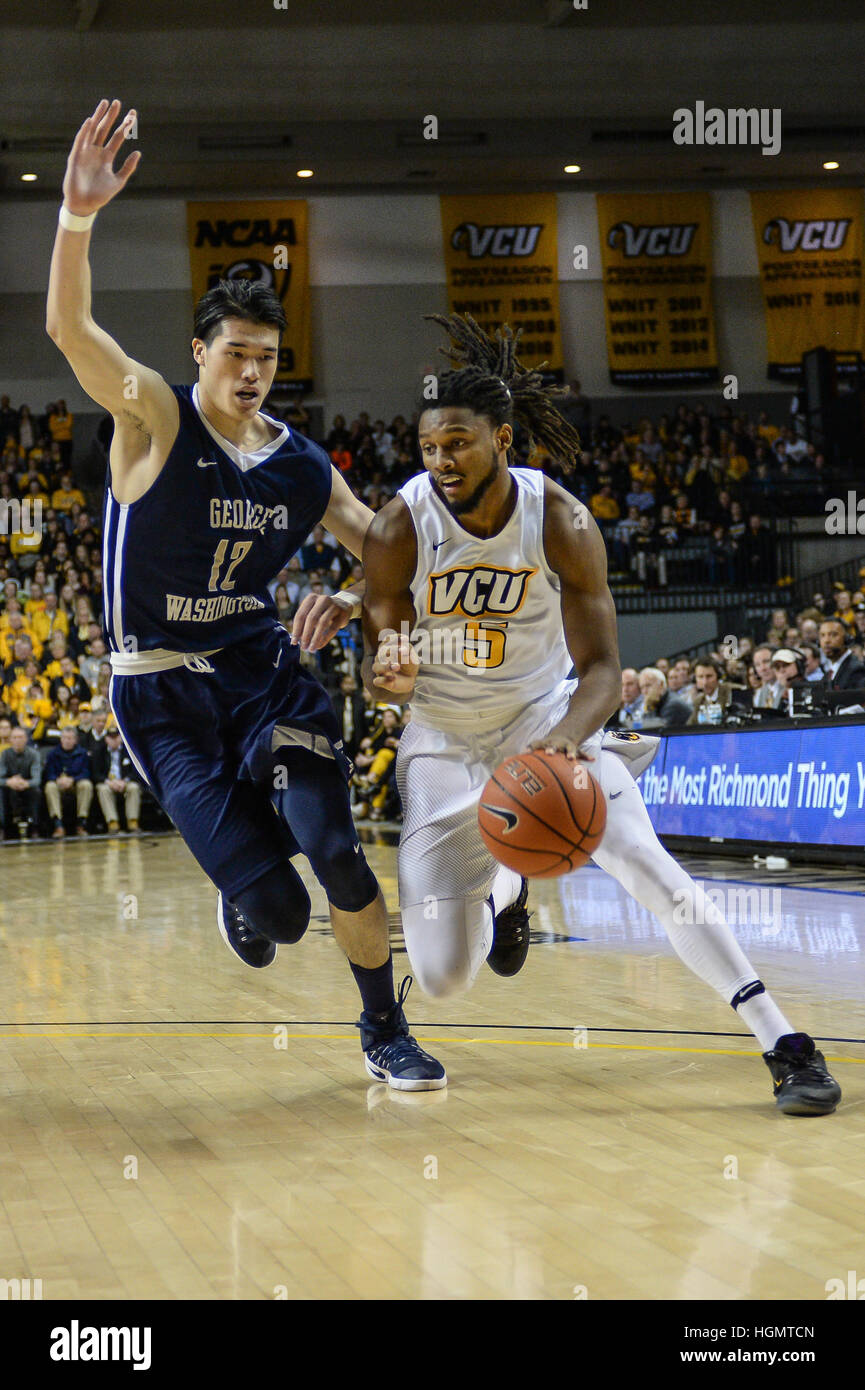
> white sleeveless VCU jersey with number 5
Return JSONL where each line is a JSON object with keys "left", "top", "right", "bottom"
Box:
{"left": 399, "top": 468, "right": 573, "bottom": 734}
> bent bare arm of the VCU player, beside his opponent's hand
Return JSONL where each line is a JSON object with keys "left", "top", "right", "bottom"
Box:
{"left": 362, "top": 498, "right": 419, "bottom": 705}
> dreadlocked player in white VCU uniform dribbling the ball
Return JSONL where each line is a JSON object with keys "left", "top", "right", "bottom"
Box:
{"left": 363, "top": 316, "right": 840, "bottom": 1115}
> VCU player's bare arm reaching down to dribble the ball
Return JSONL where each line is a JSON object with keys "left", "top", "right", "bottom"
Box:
{"left": 537, "top": 478, "right": 622, "bottom": 756}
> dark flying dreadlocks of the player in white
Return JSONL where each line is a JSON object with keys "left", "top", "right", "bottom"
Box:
{"left": 424, "top": 314, "right": 580, "bottom": 473}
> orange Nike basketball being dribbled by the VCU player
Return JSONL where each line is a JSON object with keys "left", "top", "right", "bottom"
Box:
{"left": 477, "top": 753, "right": 606, "bottom": 878}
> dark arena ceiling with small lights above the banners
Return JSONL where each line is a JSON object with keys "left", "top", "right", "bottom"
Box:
{"left": 0, "top": 0, "right": 865, "bottom": 197}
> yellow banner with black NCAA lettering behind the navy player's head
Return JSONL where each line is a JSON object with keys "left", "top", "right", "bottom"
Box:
{"left": 186, "top": 200, "right": 313, "bottom": 392}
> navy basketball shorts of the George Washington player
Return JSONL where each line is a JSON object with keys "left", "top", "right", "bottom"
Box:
{"left": 110, "top": 624, "right": 350, "bottom": 899}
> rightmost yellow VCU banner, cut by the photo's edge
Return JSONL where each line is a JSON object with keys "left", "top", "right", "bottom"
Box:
{"left": 751, "top": 188, "right": 865, "bottom": 379}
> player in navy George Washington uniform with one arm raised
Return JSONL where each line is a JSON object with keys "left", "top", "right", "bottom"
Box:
{"left": 47, "top": 101, "right": 446, "bottom": 1090}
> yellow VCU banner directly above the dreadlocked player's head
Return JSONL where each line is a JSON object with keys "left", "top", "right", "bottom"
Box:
{"left": 441, "top": 193, "right": 565, "bottom": 382}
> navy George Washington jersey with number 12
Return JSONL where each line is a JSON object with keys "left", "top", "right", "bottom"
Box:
{"left": 103, "top": 386, "right": 332, "bottom": 652}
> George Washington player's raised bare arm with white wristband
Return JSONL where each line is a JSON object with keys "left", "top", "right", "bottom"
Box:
{"left": 46, "top": 101, "right": 178, "bottom": 489}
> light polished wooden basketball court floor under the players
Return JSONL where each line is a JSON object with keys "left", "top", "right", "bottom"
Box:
{"left": 0, "top": 835, "right": 865, "bottom": 1300}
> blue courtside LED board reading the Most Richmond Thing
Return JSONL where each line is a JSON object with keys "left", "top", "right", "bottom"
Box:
{"left": 640, "top": 724, "right": 865, "bottom": 847}
